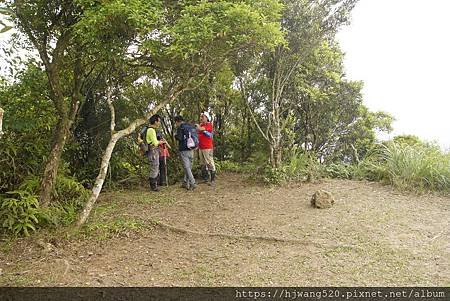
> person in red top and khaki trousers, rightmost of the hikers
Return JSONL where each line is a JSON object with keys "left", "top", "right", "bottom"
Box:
{"left": 196, "top": 112, "right": 216, "bottom": 185}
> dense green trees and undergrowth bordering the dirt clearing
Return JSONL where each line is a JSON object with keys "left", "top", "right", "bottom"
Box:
{"left": 0, "top": 0, "right": 450, "bottom": 235}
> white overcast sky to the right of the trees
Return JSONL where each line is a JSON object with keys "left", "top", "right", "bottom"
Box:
{"left": 338, "top": 0, "right": 450, "bottom": 150}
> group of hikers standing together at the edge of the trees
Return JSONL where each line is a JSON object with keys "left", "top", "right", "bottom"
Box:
{"left": 140, "top": 112, "right": 216, "bottom": 191}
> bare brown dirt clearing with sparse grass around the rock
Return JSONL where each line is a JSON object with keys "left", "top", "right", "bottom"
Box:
{"left": 0, "top": 174, "right": 450, "bottom": 286}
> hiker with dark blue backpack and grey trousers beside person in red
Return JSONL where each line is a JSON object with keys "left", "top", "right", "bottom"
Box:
{"left": 175, "top": 116, "right": 198, "bottom": 190}
